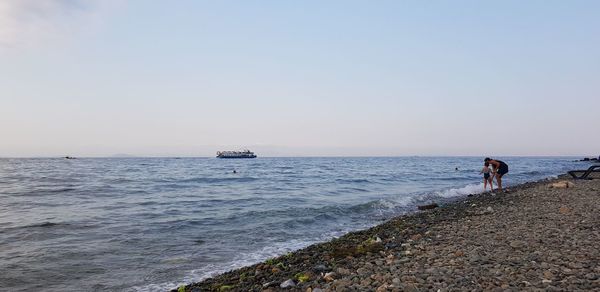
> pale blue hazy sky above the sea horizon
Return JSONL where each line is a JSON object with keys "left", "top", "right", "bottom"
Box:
{"left": 0, "top": 0, "right": 600, "bottom": 157}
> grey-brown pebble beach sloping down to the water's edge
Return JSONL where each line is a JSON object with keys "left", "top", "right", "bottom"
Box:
{"left": 178, "top": 176, "right": 600, "bottom": 292}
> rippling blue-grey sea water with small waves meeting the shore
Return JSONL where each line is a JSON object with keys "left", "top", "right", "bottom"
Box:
{"left": 0, "top": 157, "right": 587, "bottom": 291}
